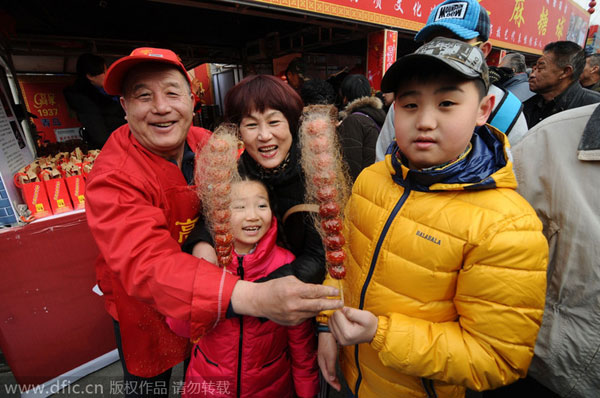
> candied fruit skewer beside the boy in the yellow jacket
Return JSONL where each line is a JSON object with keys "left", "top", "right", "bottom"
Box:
{"left": 300, "top": 105, "right": 350, "bottom": 291}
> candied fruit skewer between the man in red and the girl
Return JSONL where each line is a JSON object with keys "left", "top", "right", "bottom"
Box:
{"left": 196, "top": 124, "right": 239, "bottom": 267}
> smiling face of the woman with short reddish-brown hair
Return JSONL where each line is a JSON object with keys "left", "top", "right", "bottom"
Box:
{"left": 240, "top": 109, "right": 292, "bottom": 169}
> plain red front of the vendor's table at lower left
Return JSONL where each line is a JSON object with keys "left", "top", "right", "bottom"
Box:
{"left": 0, "top": 211, "right": 115, "bottom": 386}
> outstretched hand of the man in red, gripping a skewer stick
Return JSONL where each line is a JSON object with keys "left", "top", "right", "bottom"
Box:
{"left": 231, "top": 276, "right": 344, "bottom": 325}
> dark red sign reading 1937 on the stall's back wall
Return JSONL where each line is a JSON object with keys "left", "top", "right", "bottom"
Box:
{"left": 18, "top": 75, "right": 81, "bottom": 142}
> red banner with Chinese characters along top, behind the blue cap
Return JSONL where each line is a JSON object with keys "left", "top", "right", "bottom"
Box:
{"left": 255, "top": 0, "right": 590, "bottom": 54}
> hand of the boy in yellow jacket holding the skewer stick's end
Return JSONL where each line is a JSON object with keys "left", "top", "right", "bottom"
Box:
{"left": 329, "top": 307, "right": 378, "bottom": 345}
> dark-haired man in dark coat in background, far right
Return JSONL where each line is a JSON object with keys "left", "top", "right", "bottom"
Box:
{"left": 523, "top": 41, "right": 600, "bottom": 128}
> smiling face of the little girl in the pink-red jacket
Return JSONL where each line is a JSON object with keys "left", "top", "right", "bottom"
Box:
{"left": 231, "top": 181, "right": 273, "bottom": 254}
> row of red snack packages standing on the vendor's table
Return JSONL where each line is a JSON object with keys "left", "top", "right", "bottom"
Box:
{"left": 14, "top": 148, "right": 100, "bottom": 221}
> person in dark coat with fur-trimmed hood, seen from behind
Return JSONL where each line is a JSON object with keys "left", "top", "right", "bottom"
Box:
{"left": 338, "top": 75, "right": 386, "bottom": 181}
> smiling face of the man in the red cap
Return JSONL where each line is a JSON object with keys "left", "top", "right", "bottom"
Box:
{"left": 121, "top": 65, "right": 194, "bottom": 159}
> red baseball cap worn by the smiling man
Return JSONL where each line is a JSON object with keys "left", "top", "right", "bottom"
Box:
{"left": 104, "top": 47, "right": 192, "bottom": 95}
